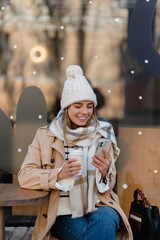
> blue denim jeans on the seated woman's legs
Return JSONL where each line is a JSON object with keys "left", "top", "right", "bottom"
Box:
{"left": 51, "top": 206, "right": 120, "bottom": 240}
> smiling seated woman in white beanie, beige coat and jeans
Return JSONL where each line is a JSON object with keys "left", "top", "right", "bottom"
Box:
{"left": 18, "top": 65, "right": 133, "bottom": 240}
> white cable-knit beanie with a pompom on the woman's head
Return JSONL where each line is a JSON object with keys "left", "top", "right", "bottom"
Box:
{"left": 61, "top": 65, "right": 97, "bottom": 109}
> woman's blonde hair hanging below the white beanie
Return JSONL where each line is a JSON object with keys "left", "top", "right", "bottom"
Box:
{"left": 62, "top": 107, "right": 98, "bottom": 144}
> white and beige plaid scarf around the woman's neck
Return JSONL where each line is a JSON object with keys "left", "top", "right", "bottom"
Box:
{"left": 49, "top": 110, "right": 119, "bottom": 217}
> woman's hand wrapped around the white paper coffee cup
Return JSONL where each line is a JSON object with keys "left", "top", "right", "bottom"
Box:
{"left": 57, "top": 158, "right": 81, "bottom": 180}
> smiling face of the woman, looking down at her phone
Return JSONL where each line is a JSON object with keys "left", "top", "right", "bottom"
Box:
{"left": 68, "top": 101, "right": 94, "bottom": 129}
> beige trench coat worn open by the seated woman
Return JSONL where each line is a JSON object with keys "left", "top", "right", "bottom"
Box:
{"left": 18, "top": 127, "right": 133, "bottom": 240}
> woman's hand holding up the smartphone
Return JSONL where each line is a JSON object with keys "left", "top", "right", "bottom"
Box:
{"left": 92, "top": 148, "right": 111, "bottom": 179}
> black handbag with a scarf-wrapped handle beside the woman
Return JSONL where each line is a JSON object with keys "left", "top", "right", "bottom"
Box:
{"left": 129, "top": 188, "right": 160, "bottom": 240}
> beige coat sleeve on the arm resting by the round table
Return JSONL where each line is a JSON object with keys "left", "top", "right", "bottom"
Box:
{"left": 18, "top": 131, "right": 58, "bottom": 190}
